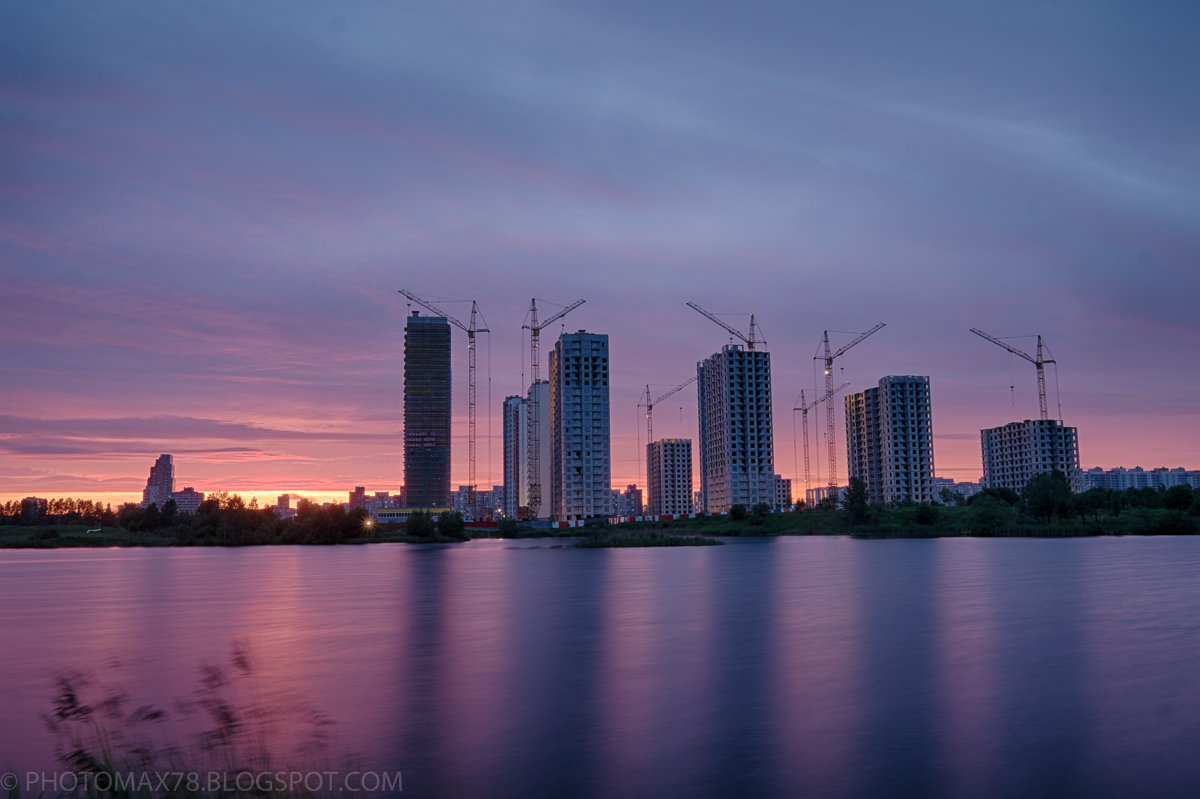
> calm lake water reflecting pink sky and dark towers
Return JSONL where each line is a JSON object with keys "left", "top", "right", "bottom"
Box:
{"left": 0, "top": 537, "right": 1200, "bottom": 798}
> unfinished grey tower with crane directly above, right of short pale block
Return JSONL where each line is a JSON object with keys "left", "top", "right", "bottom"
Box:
{"left": 696, "top": 344, "right": 775, "bottom": 513}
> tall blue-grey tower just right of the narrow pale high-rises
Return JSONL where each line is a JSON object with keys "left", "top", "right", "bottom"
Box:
{"left": 542, "top": 330, "right": 613, "bottom": 521}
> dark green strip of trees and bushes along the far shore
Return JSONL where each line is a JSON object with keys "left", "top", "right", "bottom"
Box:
{"left": 0, "top": 474, "right": 1200, "bottom": 549}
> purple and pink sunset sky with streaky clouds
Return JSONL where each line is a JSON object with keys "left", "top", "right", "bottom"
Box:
{"left": 0, "top": 0, "right": 1200, "bottom": 500}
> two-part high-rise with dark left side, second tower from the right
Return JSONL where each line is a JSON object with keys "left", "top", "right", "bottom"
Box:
{"left": 846, "top": 374, "right": 937, "bottom": 505}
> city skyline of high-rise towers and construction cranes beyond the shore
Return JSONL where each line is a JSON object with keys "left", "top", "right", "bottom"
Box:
{"left": 11, "top": 307, "right": 1200, "bottom": 527}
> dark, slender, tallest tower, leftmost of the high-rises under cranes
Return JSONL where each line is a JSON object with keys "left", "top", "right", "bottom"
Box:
{"left": 404, "top": 311, "right": 450, "bottom": 507}
